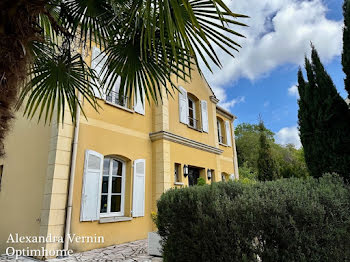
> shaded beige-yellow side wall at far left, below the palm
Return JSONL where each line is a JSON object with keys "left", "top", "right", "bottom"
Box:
{"left": 0, "top": 111, "right": 51, "bottom": 254}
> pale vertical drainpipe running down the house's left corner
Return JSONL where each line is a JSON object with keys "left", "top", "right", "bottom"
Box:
{"left": 63, "top": 92, "right": 81, "bottom": 250}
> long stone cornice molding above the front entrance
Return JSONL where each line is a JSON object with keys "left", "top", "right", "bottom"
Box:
{"left": 149, "top": 131, "right": 224, "bottom": 155}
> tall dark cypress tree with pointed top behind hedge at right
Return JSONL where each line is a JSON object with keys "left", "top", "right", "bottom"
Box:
{"left": 298, "top": 46, "right": 350, "bottom": 179}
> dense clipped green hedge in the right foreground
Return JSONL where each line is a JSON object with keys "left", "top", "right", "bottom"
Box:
{"left": 156, "top": 175, "right": 350, "bottom": 262}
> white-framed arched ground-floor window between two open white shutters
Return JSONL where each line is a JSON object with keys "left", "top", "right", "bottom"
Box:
{"left": 100, "top": 157, "right": 125, "bottom": 216}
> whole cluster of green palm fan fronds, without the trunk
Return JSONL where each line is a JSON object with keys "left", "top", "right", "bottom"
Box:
{"left": 18, "top": 0, "right": 246, "bottom": 122}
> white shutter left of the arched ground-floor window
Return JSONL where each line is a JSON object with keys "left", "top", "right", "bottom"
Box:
{"left": 80, "top": 150, "right": 103, "bottom": 221}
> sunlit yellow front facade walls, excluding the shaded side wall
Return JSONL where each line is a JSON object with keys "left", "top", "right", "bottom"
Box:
{"left": 70, "top": 59, "right": 238, "bottom": 251}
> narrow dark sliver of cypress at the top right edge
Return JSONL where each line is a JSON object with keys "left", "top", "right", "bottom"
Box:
{"left": 342, "top": 0, "right": 350, "bottom": 99}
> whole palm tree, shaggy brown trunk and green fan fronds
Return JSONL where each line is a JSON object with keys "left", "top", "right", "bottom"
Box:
{"left": 0, "top": 0, "right": 246, "bottom": 156}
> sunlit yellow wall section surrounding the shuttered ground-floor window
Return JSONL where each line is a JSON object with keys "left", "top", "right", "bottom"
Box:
{"left": 70, "top": 97, "right": 152, "bottom": 251}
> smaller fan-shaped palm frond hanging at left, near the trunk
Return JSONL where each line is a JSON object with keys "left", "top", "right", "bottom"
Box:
{"left": 17, "top": 42, "right": 98, "bottom": 123}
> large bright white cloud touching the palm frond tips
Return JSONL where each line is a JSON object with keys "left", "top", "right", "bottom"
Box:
{"left": 202, "top": 0, "right": 343, "bottom": 109}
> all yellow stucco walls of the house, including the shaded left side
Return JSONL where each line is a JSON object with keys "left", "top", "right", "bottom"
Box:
{"left": 0, "top": 45, "right": 235, "bottom": 254}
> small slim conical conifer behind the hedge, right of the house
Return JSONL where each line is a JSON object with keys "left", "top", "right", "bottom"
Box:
{"left": 258, "top": 120, "right": 278, "bottom": 181}
